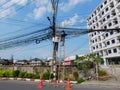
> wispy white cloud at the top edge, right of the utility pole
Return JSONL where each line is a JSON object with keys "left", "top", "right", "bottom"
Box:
{"left": 60, "top": 0, "right": 92, "bottom": 11}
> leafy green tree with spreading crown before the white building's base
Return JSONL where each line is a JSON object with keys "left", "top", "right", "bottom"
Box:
{"left": 75, "top": 53, "right": 104, "bottom": 77}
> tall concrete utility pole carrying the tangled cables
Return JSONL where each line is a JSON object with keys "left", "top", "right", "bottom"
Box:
{"left": 51, "top": 0, "right": 59, "bottom": 80}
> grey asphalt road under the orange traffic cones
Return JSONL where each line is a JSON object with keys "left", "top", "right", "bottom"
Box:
{"left": 0, "top": 80, "right": 120, "bottom": 90}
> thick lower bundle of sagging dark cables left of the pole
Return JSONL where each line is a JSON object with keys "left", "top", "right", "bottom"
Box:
{"left": 0, "top": 33, "right": 52, "bottom": 50}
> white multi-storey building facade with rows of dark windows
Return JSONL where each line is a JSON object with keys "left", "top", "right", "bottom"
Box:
{"left": 87, "top": 0, "right": 120, "bottom": 65}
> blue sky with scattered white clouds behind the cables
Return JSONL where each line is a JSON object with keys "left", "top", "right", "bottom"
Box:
{"left": 0, "top": 0, "right": 102, "bottom": 60}
